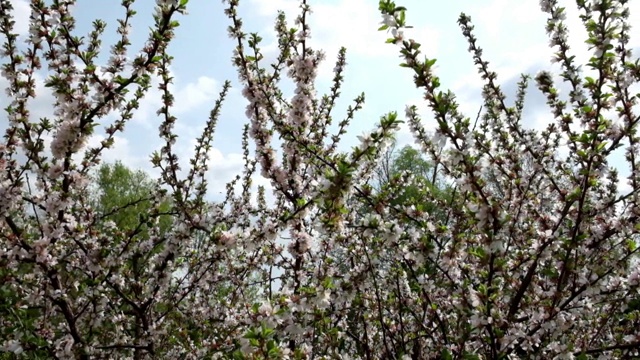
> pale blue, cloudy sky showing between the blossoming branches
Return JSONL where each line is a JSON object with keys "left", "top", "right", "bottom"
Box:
{"left": 0, "top": 0, "right": 640, "bottom": 199}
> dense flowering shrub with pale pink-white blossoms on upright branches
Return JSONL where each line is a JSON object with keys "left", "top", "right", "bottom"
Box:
{"left": 0, "top": 0, "right": 640, "bottom": 359}
